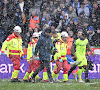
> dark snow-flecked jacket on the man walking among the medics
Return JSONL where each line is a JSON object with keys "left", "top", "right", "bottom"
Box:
{"left": 34, "top": 32, "right": 53, "bottom": 61}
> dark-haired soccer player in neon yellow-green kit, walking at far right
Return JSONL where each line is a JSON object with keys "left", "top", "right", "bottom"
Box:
{"left": 72, "top": 33, "right": 94, "bottom": 82}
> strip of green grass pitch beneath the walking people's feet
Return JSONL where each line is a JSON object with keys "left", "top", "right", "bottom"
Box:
{"left": 0, "top": 79, "right": 100, "bottom": 90}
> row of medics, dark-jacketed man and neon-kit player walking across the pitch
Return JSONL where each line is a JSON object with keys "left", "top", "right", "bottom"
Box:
{"left": 1, "top": 26, "right": 94, "bottom": 83}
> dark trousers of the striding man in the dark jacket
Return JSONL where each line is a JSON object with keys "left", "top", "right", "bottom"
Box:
{"left": 32, "top": 60, "right": 53, "bottom": 81}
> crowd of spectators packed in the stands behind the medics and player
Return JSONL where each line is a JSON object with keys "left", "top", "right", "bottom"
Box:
{"left": 0, "top": 0, "right": 100, "bottom": 48}
